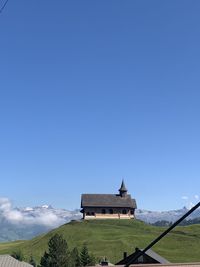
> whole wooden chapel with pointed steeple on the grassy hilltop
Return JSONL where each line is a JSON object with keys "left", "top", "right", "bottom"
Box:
{"left": 81, "top": 181, "right": 137, "bottom": 220}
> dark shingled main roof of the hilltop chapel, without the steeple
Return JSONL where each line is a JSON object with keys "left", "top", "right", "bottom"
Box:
{"left": 81, "top": 194, "right": 137, "bottom": 209}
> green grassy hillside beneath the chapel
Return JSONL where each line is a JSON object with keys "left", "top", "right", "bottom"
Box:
{"left": 0, "top": 220, "right": 200, "bottom": 263}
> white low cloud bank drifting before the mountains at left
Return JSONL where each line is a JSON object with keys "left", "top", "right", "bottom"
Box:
{"left": 0, "top": 198, "right": 66, "bottom": 227}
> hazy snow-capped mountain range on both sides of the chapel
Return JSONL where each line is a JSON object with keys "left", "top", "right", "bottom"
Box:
{"left": 0, "top": 199, "right": 200, "bottom": 242}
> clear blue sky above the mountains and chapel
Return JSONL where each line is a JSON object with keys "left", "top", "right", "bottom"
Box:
{"left": 0, "top": 0, "right": 200, "bottom": 213}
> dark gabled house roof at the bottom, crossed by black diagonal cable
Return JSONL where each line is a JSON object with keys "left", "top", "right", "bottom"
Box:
{"left": 115, "top": 249, "right": 170, "bottom": 265}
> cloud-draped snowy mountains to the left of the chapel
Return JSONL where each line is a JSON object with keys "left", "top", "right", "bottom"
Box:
{"left": 0, "top": 201, "right": 81, "bottom": 242}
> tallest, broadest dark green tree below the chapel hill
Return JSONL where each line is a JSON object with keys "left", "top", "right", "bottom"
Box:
{"left": 40, "top": 234, "right": 69, "bottom": 267}
